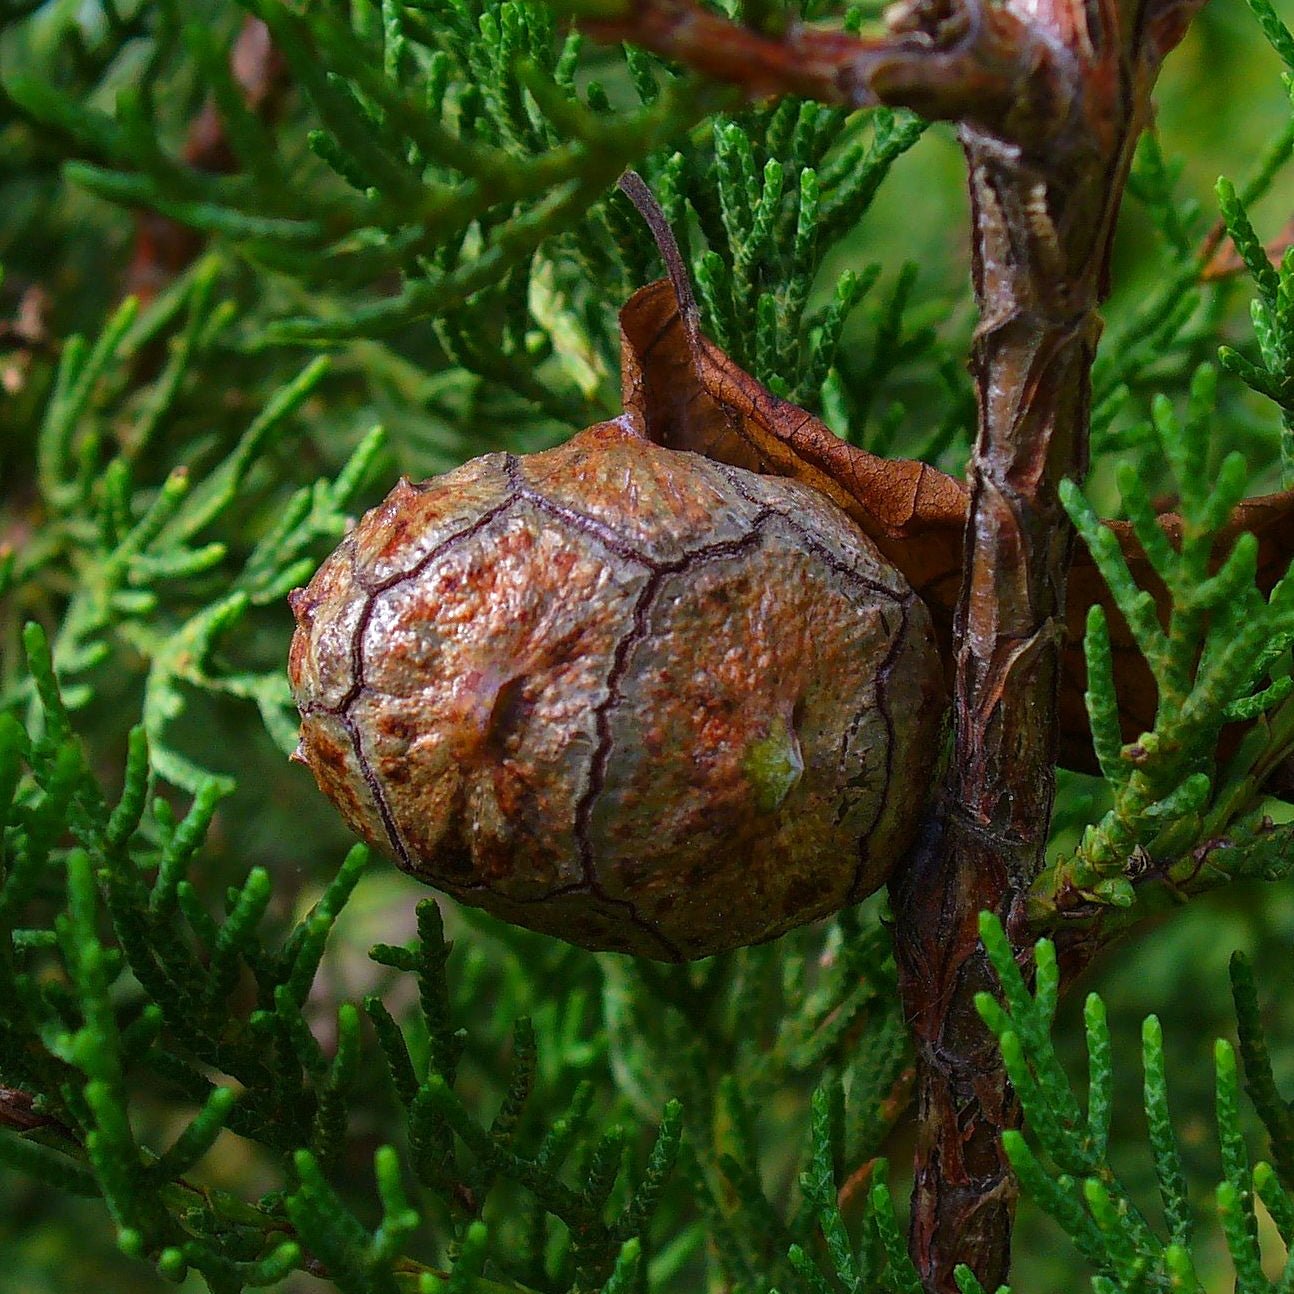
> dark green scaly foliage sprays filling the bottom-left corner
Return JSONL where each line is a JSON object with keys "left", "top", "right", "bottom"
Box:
{"left": 0, "top": 625, "right": 698, "bottom": 1294}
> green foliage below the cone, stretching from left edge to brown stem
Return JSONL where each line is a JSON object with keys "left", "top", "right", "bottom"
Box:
{"left": 0, "top": 626, "right": 931, "bottom": 1291}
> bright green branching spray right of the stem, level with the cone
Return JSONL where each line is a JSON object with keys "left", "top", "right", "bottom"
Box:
{"left": 1035, "top": 367, "right": 1294, "bottom": 914}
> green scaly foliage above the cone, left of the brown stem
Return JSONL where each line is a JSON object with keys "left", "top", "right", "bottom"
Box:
{"left": 5, "top": 0, "right": 973, "bottom": 454}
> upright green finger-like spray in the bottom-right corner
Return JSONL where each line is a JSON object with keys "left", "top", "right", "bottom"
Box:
{"left": 961, "top": 914, "right": 1294, "bottom": 1294}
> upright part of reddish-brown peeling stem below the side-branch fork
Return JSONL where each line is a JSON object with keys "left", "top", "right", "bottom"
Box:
{"left": 892, "top": 114, "right": 1135, "bottom": 1291}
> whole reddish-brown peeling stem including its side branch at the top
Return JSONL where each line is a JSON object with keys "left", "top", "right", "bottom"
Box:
{"left": 587, "top": 0, "right": 1201, "bottom": 1278}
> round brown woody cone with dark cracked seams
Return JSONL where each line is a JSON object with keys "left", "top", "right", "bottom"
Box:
{"left": 290, "top": 421, "right": 943, "bottom": 960}
